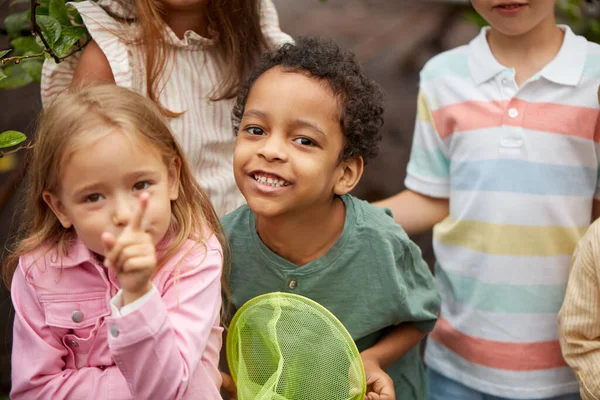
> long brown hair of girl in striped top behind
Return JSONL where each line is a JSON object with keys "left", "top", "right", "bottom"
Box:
{"left": 133, "top": 0, "right": 267, "bottom": 117}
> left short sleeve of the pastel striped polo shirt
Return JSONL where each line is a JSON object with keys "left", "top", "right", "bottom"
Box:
{"left": 405, "top": 89, "right": 450, "bottom": 198}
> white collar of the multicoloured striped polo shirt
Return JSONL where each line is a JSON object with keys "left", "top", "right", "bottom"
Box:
{"left": 469, "top": 25, "right": 587, "bottom": 86}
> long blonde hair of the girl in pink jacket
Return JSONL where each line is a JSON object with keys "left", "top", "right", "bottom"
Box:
{"left": 3, "top": 85, "right": 230, "bottom": 298}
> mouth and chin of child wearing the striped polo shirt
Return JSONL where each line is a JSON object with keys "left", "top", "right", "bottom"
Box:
{"left": 471, "top": 0, "right": 556, "bottom": 36}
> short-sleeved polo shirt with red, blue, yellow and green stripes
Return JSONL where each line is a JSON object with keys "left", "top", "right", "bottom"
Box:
{"left": 405, "top": 26, "right": 600, "bottom": 398}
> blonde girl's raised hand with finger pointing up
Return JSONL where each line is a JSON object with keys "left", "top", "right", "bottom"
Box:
{"left": 102, "top": 193, "right": 156, "bottom": 305}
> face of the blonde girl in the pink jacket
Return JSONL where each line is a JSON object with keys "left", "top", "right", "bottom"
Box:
{"left": 43, "top": 131, "right": 181, "bottom": 255}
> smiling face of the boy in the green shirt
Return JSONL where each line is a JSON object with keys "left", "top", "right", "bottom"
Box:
{"left": 234, "top": 67, "right": 362, "bottom": 217}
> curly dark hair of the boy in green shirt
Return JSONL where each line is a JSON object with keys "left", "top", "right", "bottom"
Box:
{"left": 232, "top": 37, "right": 383, "bottom": 163}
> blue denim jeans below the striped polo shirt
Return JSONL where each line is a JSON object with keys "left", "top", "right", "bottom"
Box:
{"left": 427, "top": 369, "right": 581, "bottom": 400}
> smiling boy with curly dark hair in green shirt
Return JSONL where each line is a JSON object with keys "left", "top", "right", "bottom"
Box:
{"left": 222, "top": 38, "right": 440, "bottom": 400}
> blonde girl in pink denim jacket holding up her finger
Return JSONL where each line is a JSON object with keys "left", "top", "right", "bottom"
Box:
{"left": 3, "top": 85, "right": 228, "bottom": 400}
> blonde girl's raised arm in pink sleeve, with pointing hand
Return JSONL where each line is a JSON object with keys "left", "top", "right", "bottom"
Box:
{"left": 102, "top": 193, "right": 223, "bottom": 399}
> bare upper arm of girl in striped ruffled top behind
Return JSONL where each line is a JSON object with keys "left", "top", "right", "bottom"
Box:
{"left": 71, "top": 40, "right": 115, "bottom": 88}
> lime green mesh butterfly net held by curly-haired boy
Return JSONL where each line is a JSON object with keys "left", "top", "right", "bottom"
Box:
{"left": 227, "top": 292, "right": 367, "bottom": 400}
